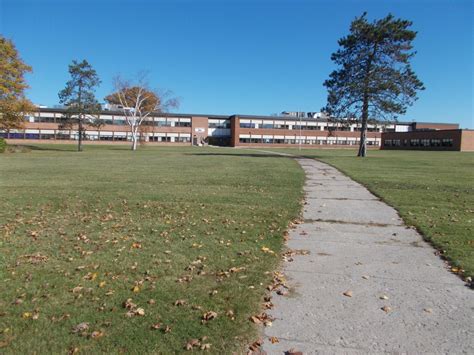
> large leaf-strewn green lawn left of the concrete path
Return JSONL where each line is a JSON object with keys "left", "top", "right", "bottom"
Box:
{"left": 0, "top": 145, "right": 304, "bottom": 354}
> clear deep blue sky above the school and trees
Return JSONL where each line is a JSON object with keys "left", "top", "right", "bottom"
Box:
{"left": 0, "top": 0, "right": 474, "bottom": 128}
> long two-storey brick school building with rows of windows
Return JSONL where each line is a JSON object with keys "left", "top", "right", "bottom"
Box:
{"left": 0, "top": 108, "right": 472, "bottom": 150}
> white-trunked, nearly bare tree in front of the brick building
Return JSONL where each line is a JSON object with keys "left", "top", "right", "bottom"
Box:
{"left": 105, "top": 73, "right": 179, "bottom": 150}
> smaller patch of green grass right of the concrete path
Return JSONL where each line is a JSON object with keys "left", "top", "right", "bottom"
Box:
{"left": 270, "top": 149, "right": 474, "bottom": 278}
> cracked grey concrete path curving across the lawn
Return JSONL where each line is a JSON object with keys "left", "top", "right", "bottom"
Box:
{"left": 262, "top": 159, "right": 474, "bottom": 354}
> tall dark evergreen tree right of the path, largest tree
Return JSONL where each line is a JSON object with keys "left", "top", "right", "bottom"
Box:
{"left": 323, "top": 13, "right": 424, "bottom": 157}
